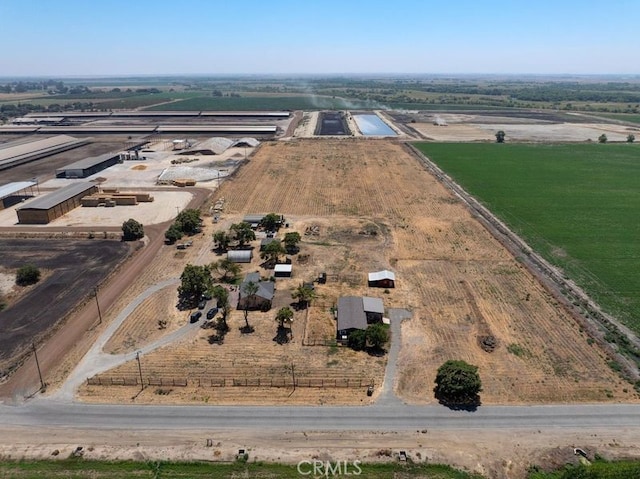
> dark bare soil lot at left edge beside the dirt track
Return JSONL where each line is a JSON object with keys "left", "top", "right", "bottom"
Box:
{"left": 0, "top": 239, "right": 129, "bottom": 376}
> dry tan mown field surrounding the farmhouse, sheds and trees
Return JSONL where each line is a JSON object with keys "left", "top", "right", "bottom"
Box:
{"left": 75, "top": 139, "right": 637, "bottom": 404}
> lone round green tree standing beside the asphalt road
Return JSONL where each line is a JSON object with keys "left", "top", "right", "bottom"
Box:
{"left": 434, "top": 360, "right": 482, "bottom": 405}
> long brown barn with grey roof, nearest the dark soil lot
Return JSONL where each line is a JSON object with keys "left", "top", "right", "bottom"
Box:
{"left": 16, "top": 181, "right": 98, "bottom": 224}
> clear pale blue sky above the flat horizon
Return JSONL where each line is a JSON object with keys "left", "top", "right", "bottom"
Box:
{"left": 0, "top": 0, "right": 640, "bottom": 77}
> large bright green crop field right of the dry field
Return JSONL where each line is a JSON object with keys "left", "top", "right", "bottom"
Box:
{"left": 416, "top": 143, "right": 640, "bottom": 333}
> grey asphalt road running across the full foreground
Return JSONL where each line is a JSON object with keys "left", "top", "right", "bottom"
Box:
{"left": 0, "top": 398, "right": 640, "bottom": 431}
